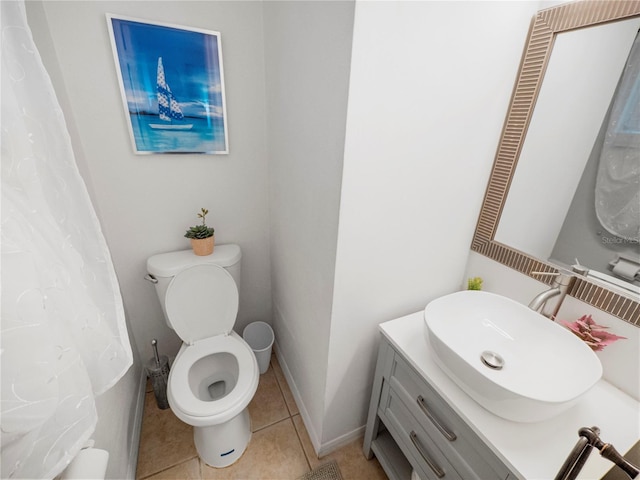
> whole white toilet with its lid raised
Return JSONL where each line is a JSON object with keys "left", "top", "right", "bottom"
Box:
{"left": 147, "top": 245, "right": 260, "bottom": 468}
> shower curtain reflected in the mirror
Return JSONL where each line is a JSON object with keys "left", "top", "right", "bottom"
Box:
{"left": 596, "top": 31, "right": 640, "bottom": 243}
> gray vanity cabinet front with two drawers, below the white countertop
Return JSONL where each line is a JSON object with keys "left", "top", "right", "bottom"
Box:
{"left": 364, "top": 336, "right": 515, "bottom": 480}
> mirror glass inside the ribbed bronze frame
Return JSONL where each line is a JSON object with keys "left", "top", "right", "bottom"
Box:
{"left": 495, "top": 18, "right": 640, "bottom": 292}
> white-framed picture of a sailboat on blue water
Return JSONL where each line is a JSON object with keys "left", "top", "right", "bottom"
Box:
{"left": 107, "top": 14, "right": 229, "bottom": 154}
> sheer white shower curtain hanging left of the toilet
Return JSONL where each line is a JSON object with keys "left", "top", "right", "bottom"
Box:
{"left": 0, "top": 0, "right": 132, "bottom": 478}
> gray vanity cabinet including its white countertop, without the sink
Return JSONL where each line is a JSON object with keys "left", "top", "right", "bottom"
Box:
{"left": 364, "top": 312, "right": 640, "bottom": 480}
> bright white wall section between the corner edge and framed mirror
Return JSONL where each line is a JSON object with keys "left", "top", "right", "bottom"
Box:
{"left": 321, "top": 2, "right": 539, "bottom": 448}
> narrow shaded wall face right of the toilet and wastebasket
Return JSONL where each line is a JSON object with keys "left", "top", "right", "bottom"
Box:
{"left": 264, "top": 0, "right": 354, "bottom": 445}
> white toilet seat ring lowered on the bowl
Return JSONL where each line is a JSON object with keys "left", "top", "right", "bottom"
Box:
{"left": 167, "top": 332, "right": 258, "bottom": 423}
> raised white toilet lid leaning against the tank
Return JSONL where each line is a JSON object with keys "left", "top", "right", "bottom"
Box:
{"left": 165, "top": 265, "right": 238, "bottom": 344}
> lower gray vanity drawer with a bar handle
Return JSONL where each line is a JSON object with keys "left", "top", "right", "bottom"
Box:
{"left": 378, "top": 385, "right": 463, "bottom": 480}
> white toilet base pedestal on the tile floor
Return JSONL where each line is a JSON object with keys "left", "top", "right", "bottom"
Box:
{"left": 193, "top": 408, "right": 251, "bottom": 468}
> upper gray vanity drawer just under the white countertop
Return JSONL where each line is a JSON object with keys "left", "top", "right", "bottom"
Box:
{"left": 389, "top": 354, "right": 509, "bottom": 480}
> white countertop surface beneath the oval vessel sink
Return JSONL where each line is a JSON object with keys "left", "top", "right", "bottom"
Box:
{"left": 380, "top": 312, "right": 640, "bottom": 480}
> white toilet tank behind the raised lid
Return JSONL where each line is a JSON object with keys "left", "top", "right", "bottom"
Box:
{"left": 147, "top": 243, "right": 242, "bottom": 329}
